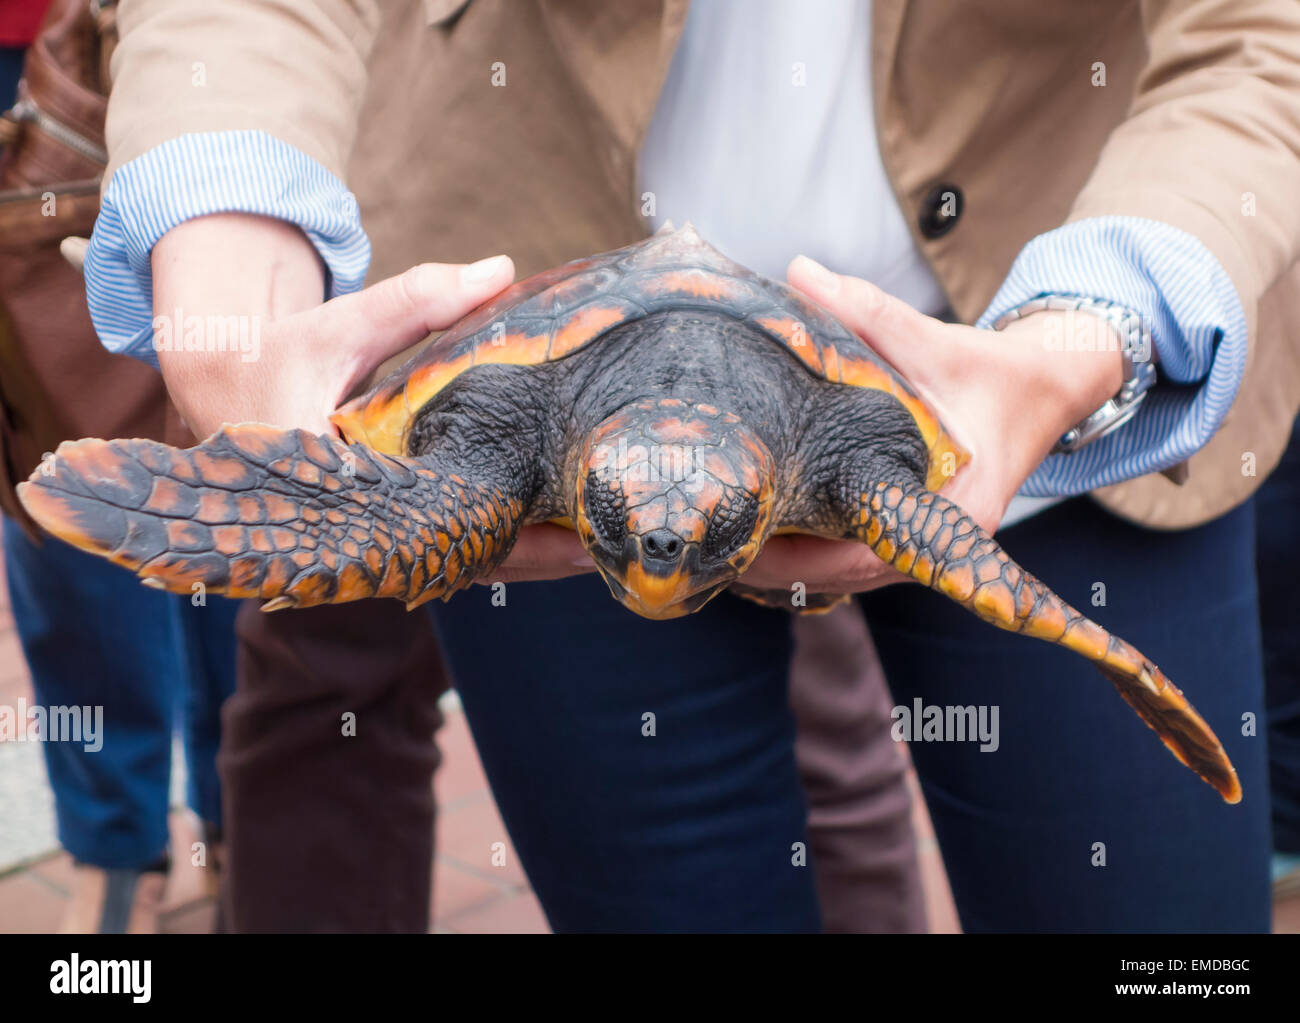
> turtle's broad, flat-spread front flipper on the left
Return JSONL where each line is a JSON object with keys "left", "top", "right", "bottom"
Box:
{"left": 18, "top": 424, "right": 523, "bottom": 610}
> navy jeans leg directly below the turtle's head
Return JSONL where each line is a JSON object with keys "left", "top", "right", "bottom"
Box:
{"left": 423, "top": 576, "right": 819, "bottom": 932}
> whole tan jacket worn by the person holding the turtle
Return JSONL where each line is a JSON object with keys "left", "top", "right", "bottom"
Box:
{"left": 108, "top": 0, "right": 1300, "bottom": 528}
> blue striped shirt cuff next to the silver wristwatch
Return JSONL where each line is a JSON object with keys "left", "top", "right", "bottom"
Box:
{"left": 976, "top": 217, "right": 1247, "bottom": 497}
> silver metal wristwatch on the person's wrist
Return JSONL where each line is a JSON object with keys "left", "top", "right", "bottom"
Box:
{"left": 993, "top": 295, "right": 1156, "bottom": 455}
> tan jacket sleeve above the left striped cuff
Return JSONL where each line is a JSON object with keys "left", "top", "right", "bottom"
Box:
{"left": 105, "top": 0, "right": 378, "bottom": 182}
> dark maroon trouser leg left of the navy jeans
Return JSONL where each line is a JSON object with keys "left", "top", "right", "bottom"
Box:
{"left": 217, "top": 601, "right": 446, "bottom": 932}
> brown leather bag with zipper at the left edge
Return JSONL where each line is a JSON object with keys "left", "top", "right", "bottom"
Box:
{"left": 0, "top": 0, "right": 194, "bottom": 536}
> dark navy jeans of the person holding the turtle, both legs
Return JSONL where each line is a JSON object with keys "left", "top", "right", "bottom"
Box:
{"left": 433, "top": 500, "right": 1269, "bottom": 931}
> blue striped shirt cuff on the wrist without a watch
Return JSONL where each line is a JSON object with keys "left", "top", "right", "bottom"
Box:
{"left": 85, "top": 131, "right": 371, "bottom": 367}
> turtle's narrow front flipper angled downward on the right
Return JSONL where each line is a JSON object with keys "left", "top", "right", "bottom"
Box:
{"left": 852, "top": 484, "right": 1242, "bottom": 803}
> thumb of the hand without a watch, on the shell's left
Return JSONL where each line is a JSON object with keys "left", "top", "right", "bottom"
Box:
{"left": 311, "top": 256, "right": 515, "bottom": 365}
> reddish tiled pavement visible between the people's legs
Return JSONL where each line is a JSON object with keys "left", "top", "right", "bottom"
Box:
{"left": 0, "top": 548, "right": 1300, "bottom": 933}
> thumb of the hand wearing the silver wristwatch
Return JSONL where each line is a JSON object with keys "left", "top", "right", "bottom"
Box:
{"left": 785, "top": 256, "right": 937, "bottom": 380}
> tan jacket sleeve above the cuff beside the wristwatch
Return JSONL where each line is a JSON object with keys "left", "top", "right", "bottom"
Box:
{"left": 1070, "top": 0, "right": 1300, "bottom": 348}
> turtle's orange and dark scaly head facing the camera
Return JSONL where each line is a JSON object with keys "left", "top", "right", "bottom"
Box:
{"left": 575, "top": 398, "right": 775, "bottom": 619}
